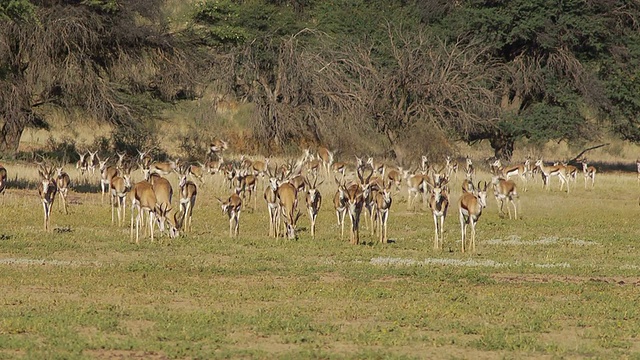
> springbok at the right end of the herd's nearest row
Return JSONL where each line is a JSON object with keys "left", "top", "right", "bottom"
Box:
{"left": 458, "top": 181, "right": 488, "bottom": 252}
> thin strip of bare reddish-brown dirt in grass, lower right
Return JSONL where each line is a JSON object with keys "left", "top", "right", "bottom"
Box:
{"left": 491, "top": 274, "right": 640, "bottom": 286}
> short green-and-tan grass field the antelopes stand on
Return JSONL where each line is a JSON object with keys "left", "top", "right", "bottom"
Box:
{"left": 0, "top": 164, "right": 640, "bottom": 359}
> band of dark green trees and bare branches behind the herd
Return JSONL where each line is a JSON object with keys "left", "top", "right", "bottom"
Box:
{"left": 0, "top": 0, "right": 640, "bottom": 159}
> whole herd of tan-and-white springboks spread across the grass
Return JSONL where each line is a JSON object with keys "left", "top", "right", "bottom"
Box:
{"left": 0, "top": 140, "right": 608, "bottom": 252}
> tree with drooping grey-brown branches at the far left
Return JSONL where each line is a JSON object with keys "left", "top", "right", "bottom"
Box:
{"left": 0, "top": 0, "right": 204, "bottom": 152}
